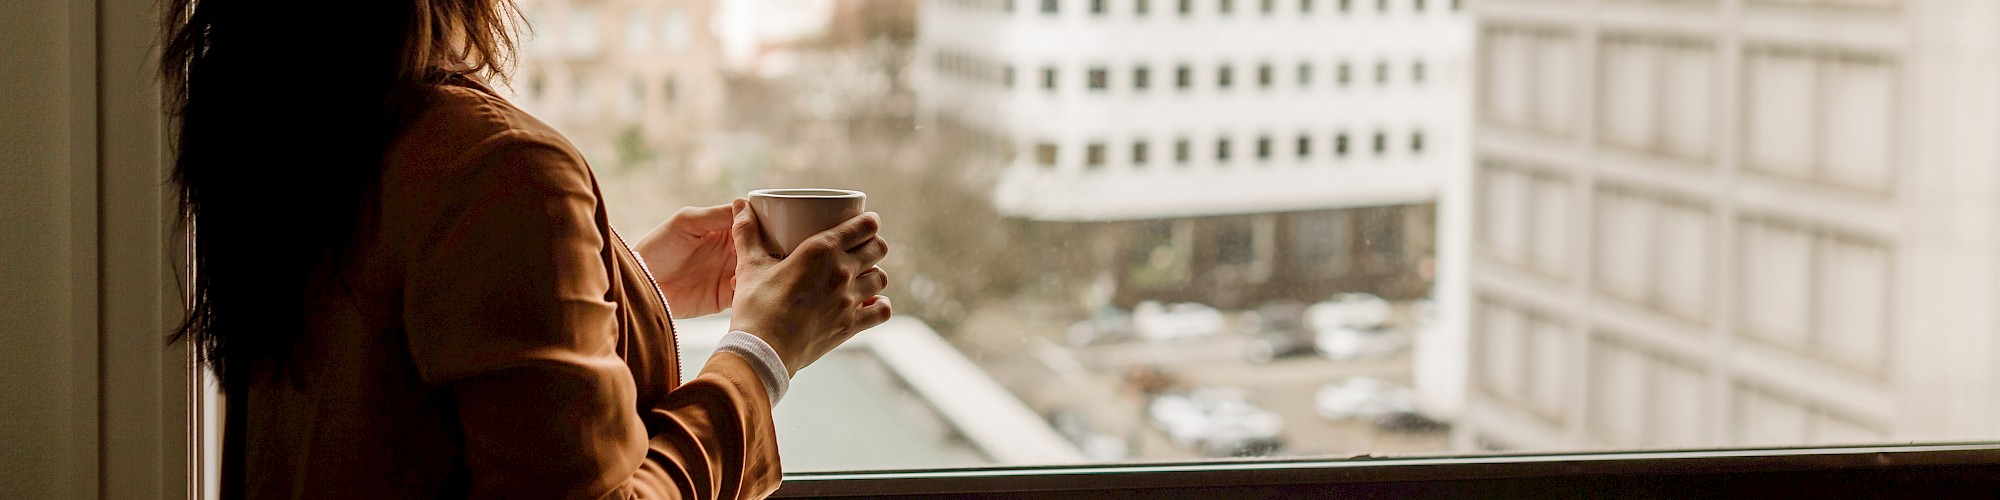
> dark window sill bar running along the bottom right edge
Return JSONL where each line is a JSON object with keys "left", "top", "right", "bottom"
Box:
{"left": 772, "top": 442, "right": 2000, "bottom": 498}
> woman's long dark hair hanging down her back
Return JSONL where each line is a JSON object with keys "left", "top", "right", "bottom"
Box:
{"left": 160, "top": 0, "right": 518, "bottom": 388}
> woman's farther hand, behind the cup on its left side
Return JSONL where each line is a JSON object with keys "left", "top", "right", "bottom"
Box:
{"left": 634, "top": 204, "right": 736, "bottom": 318}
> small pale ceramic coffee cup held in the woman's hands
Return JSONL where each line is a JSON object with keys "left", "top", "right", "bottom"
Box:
{"left": 750, "top": 188, "right": 868, "bottom": 256}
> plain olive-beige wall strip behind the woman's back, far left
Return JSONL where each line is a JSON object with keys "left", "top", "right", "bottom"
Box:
{"left": 0, "top": 0, "right": 200, "bottom": 498}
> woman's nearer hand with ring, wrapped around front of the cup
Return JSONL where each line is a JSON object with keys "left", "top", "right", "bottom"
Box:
{"left": 730, "top": 198, "right": 890, "bottom": 376}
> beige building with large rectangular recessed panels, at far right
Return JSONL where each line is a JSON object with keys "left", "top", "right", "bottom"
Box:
{"left": 1458, "top": 0, "right": 2000, "bottom": 450}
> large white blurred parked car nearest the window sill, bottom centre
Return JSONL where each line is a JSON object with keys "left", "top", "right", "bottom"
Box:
{"left": 1146, "top": 388, "right": 1284, "bottom": 456}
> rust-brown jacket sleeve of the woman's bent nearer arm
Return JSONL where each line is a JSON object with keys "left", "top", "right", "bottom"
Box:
{"left": 398, "top": 130, "right": 780, "bottom": 498}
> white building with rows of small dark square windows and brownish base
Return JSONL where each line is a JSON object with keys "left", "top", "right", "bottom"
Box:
{"left": 914, "top": 0, "right": 1470, "bottom": 308}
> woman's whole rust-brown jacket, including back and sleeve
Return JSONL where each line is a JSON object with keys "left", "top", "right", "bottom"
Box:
{"left": 224, "top": 82, "right": 780, "bottom": 498}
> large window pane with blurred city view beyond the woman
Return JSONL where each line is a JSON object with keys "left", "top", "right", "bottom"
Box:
{"left": 508, "top": 0, "right": 2000, "bottom": 472}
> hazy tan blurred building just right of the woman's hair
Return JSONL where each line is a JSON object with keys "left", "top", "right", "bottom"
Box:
{"left": 512, "top": 0, "right": 726, "bottom": 184}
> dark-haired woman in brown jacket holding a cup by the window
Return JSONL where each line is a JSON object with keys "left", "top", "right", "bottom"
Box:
{"left": 148, "top": 0, "right": 890, "bottom": 498}
